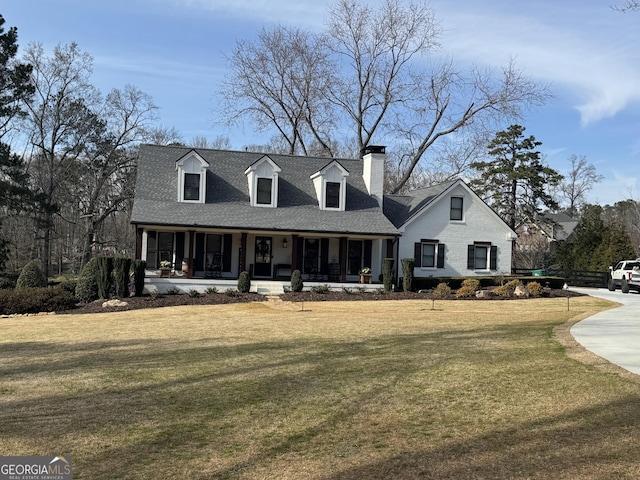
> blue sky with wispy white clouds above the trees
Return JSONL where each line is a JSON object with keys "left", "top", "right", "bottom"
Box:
{"left": 0, "top": 0, "right": 640, "bottom": 204}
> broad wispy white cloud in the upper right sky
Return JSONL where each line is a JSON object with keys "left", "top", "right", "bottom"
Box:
{"left": 436, "top": 1, "right": 640, "bottom": 126}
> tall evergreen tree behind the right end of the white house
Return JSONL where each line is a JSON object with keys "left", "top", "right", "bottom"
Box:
{"left": 470, "top": 125, "right": 563, "bottom": 229}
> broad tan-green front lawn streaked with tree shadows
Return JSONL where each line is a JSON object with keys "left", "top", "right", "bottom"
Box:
{"left": 0, "top": 297, "right": 640, "bottom": 480}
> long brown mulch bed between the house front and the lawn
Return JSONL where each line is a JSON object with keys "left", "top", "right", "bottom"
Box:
{"left": 65, "top": 290, "right": 582, "bottom": 314}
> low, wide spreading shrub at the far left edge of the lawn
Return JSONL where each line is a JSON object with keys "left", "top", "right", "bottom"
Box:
{"left": 0, "top": 287, "right": 78, "bottom": 315}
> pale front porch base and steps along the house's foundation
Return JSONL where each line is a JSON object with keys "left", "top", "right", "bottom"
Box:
{"left": 144, "top": 276, "right": 384, "bottom": 295}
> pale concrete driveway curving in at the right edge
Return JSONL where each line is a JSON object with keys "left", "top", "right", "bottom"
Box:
{"left": 570, "top": 287, "right": 640, "bottom": 375}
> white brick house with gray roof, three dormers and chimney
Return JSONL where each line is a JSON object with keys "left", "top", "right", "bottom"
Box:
{"left": 131, "top": 145, "right": 515, "bottom": 290}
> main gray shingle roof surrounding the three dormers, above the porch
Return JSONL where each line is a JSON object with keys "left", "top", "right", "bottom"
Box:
{"left": 131, "top": 145, "right": 398, "bottom": 235}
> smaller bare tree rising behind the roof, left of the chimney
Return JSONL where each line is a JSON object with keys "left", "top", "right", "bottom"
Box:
{"left": 220, "top": 26, "right": 334, "bottom": 154}
